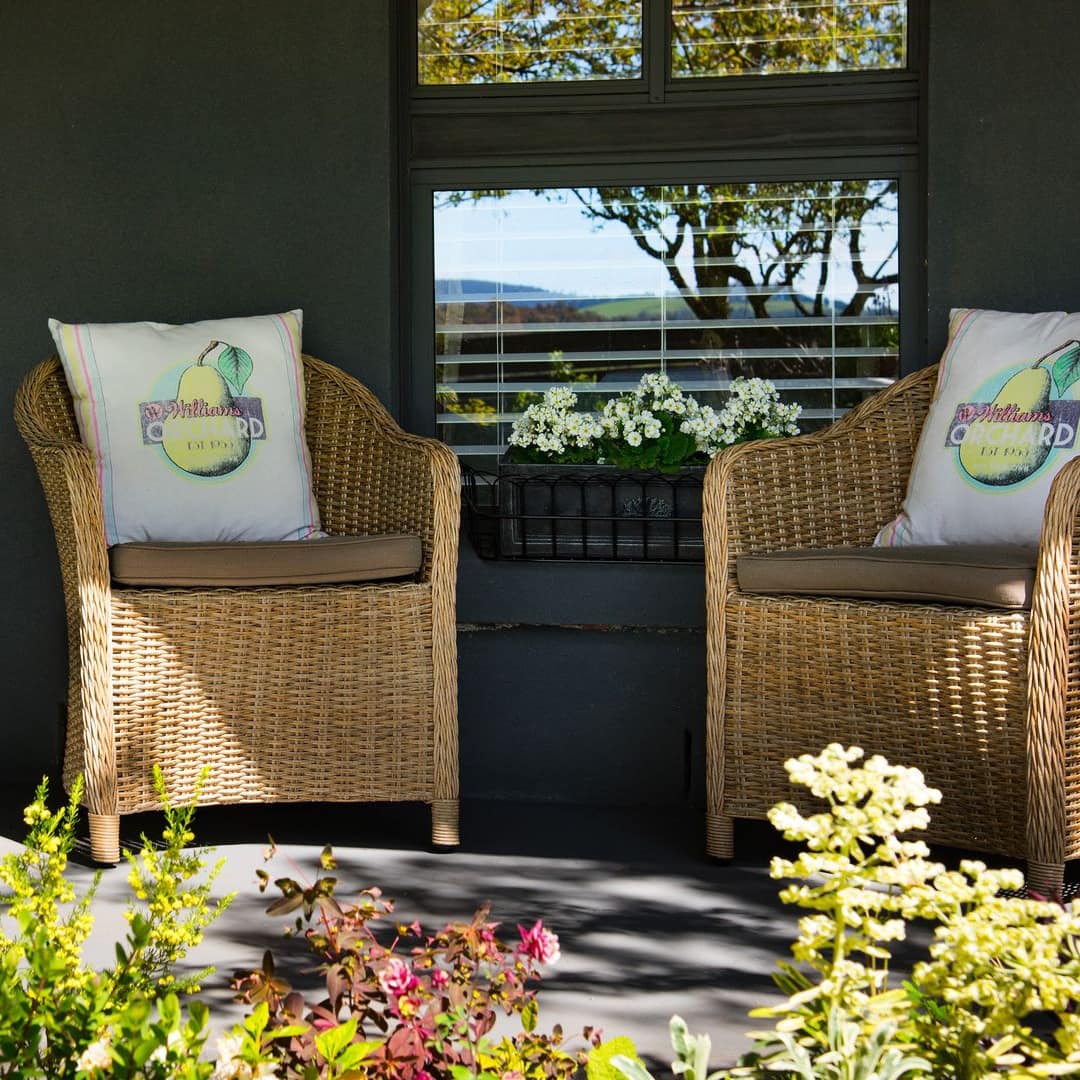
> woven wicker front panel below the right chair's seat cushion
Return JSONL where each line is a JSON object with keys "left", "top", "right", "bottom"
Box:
{"left": 721, "top": 594, "right": 1027, "bottom": 854}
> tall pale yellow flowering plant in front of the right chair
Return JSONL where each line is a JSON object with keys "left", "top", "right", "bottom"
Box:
{"left": 612, "top": 744, "right": 1080, "bottom": 1080}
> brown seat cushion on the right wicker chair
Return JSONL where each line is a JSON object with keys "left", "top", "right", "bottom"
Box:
{"left": 737, "top": 544, "right": 1038, "bottom": 609}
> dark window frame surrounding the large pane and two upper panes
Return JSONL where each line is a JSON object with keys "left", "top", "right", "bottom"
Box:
{"left": 395, "top": 0, "right": 928, "bottom": 435}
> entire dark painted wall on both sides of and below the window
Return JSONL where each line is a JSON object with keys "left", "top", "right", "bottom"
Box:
{"left": 0, "top": 0, "right": 1080, "bottom": 801}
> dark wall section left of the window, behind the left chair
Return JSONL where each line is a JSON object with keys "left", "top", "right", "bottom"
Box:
{"left": 0, "top": 0, "right": 397, "bottom": 778}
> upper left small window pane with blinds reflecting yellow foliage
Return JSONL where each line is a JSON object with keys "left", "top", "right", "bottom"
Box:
{"left": 417, "top": 0, "right": 642, "bottom": 85}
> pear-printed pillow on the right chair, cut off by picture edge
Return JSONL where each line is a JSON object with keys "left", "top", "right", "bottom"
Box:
{"left": 875, "top": 308, "right": 1080, "bottom": 546}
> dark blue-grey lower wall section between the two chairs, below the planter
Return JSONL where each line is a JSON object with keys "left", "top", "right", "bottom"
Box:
{"left": 458, "top": 626, "right": 705, "bottom": 806}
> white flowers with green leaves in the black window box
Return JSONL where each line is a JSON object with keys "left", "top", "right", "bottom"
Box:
{"left": 509, "top": 372, "right": 801, "bottom": 472}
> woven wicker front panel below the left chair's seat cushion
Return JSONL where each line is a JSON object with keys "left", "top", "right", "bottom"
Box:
{"left": 112, "top": 584, "right": 434, "bottom": 813}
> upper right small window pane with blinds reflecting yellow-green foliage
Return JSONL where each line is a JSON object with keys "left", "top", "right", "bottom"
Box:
{"left": 672, "top": 0, "right": 907, "bottom": 78}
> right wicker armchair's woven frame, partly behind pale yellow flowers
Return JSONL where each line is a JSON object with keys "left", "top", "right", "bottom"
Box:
{"left": 704, "top": 367, "right": 1080, "bottom": 890}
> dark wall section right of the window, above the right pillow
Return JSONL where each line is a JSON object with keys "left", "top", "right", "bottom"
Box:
{"left": 927, "top": 0, "right": 1080, "bottom": 360}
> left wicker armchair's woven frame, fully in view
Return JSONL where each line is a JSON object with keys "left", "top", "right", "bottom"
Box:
{"left": 15, "top": 356, "right": 460, "bottom": 862}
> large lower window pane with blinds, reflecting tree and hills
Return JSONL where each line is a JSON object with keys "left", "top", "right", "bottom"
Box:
{"left": 434, "top": 179, "right": 899, "bottom": 464}
